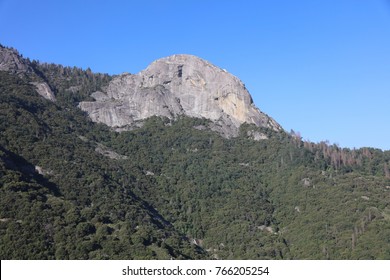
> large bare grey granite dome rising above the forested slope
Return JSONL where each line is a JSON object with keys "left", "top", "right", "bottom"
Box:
{"left": 79, "top": 55, "right": 282, "bottom": 137}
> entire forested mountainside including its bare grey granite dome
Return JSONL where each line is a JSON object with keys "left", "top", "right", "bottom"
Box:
{"left": 0, "top": 46, "right": 390, "bottom": 259}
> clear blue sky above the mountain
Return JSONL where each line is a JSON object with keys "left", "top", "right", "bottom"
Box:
{"left": 0, "top": 0, "right": 390, "bottom": 150}
